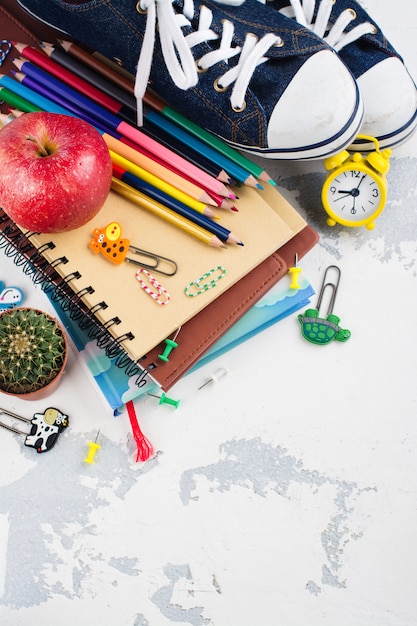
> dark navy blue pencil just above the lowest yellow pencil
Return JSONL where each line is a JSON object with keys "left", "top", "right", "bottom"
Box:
{"left": 113, "top": 165, "right": 243, "bottom": 246}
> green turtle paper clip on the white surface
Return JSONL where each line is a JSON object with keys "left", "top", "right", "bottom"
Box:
{"left": 298, "top": 265, "right": 351, "bottom": 345}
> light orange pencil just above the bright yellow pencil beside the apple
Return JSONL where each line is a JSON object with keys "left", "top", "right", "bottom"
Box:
{"left": 102, "top": 133, "right": 213, "bottom": 204}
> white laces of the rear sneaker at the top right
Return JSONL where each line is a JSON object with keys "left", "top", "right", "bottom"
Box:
{"left": 280, "top": 0, "right": 375, "bottom": 52}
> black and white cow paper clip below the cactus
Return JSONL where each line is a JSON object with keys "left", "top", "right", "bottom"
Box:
{"left": 0, "top": 407, "right": 69, "bottom": 453}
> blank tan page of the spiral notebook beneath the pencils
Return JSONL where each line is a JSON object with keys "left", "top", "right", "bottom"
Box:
{"left": 22, "top": 187, "right": 300, "bottom": 360}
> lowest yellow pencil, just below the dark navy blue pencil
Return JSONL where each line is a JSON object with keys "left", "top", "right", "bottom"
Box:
{"left": 111, "top": 176, "right": 224, "bottom": 248}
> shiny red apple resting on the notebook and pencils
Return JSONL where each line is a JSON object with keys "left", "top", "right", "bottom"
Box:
{"left": 0, "top": 111, "right": 112, "bottom": 233}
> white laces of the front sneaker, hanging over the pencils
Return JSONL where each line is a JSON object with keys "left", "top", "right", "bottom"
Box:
{"left": 135, "top": 0, "right": 282, "bottom": 125}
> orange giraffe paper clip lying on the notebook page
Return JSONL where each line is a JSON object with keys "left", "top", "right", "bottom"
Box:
{"left": 89, "top": 222, "right": 178, "bottom": 276}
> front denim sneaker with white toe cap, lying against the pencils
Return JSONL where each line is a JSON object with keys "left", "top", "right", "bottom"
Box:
{"left": 18, "top": 0, "right": 363, "bottom": 160}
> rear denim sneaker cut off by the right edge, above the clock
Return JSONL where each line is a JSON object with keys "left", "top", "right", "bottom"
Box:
{"left": 261, "top": 0, "right": 417, "bottom": 150}
